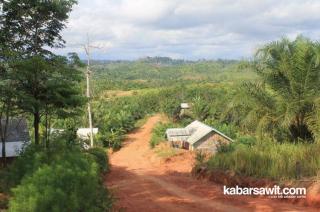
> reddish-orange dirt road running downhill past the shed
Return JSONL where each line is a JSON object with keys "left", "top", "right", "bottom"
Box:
{"left": 105, "top": 115, "right": 316, "bottom": 212}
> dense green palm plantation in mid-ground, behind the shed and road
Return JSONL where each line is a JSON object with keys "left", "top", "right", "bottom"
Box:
{"left": 94, "top": 85, "right": 233, "bottom": 149}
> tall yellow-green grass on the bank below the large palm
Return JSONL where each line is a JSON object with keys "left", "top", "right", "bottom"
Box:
{"left": 208, "top": 141, "right": 320, "bottom": 180}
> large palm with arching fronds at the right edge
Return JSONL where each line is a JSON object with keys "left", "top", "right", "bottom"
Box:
{"left": 226, "top": 36, "right": 320, "bottom": 141}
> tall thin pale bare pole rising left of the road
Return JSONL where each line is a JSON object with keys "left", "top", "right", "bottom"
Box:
{"left": 84, "top": 36, "right": 93, "bottom": 148}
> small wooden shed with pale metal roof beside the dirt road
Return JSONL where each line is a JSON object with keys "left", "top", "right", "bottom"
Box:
{"left": 166, "top": 121, "right": 233, "bottom": 152}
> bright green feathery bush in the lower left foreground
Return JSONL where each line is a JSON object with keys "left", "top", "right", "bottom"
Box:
{"left": 9, "top": 153, "right": 111, "bottom": 212}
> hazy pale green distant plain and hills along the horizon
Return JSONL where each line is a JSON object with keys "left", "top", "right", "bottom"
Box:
{"left": 93, "top": 58, "right": 256, "bottom": 95}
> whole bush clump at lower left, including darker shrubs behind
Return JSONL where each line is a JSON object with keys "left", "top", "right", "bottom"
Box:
{"left": 8, "top": 140, "right": 112, "bottom": 211}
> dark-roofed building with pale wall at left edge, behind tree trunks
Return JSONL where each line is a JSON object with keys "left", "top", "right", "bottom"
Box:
{"left": 0, "top": 118, "right": 31, "bottom": 158}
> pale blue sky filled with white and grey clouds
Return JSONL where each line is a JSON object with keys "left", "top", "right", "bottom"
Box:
{"left": 58, "top": 0, "right": 320, "bottom": 60}
